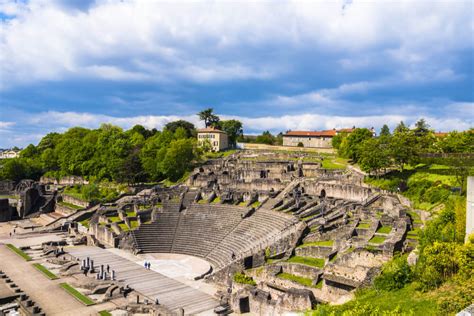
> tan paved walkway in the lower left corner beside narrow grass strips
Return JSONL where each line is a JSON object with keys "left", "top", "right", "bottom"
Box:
{"left": 0, "top": 244, "right": 112, "bottom": 316}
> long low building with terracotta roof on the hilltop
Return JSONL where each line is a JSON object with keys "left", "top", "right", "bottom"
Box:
{"left": 283, "top": 127, "right": 362, "bottom": 148}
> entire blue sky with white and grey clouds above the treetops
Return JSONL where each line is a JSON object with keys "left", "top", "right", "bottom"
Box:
{"left": 0, "top": 0, "right": 474, "bottom": 148}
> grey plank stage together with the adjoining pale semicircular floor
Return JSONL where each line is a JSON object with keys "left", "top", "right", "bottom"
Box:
{"left": 67, "top": 246, "right": 219, "bottom": 314}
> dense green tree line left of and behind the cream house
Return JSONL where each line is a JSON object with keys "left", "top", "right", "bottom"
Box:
{"left": 0, "top": 109, "right": 243, "bottom": 183}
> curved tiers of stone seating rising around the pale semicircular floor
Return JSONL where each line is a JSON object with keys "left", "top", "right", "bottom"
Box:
{"left": 132, "top": 203, "right": 298, "bottom": 270}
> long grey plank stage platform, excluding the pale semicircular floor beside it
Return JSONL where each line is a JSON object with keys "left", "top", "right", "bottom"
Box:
{"left": 67, "top": 246, "right": 219, "bottom": 314}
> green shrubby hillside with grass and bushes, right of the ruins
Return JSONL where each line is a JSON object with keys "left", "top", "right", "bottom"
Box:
{"left": 308, "top": 164, "right": 474, "bottom": 315}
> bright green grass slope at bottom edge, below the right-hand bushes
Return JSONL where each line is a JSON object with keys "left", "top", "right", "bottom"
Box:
{"left": 306, "top": 285, "right": 438, "bottom": 316}
